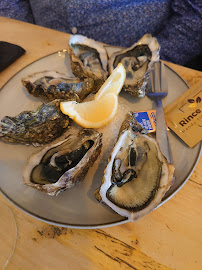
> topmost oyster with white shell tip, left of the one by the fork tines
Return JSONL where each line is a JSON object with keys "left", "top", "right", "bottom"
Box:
{"left": 67, "top": 35, "right": 108, "bottom": 89}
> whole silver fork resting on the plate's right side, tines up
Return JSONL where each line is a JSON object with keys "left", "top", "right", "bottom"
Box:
{"left": 147, "top": 62, "right": 172, "bottom": 163}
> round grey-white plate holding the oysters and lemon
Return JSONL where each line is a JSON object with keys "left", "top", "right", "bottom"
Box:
{"left": 0, "top": 48, "right": 201, "bottom": 228}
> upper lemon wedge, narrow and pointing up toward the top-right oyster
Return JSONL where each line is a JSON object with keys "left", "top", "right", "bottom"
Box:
{"left": 94, "top": 63, "right": 126, "bottom": 99}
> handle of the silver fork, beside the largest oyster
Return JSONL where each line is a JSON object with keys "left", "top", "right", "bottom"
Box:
{"left": 156, "top": 100, "right": 172, "bottom": 163}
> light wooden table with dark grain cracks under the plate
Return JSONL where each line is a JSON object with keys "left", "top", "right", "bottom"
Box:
{"left": 0, "top": 17, "right": 202, "bottom": 270}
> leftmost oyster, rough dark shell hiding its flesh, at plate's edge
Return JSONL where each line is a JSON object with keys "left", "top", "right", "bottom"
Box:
{"left": 0, "top": 99, "right": 69, "bottom": 144}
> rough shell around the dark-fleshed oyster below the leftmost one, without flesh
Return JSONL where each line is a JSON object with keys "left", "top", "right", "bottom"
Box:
{"left": 23, "top": 129, "right": 102, "bottom": 196}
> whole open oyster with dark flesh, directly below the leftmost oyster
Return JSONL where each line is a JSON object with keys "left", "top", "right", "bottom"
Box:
{"left": 23, "top": 129, "right": 102, "bottom": 195}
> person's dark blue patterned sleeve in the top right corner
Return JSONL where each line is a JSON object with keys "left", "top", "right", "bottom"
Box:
{"left": 157, "top": 0, "right": 202, "bottom": 65}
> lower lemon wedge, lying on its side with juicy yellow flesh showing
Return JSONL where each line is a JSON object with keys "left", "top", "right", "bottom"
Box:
{"left": 60, "top": 93, "right": 118, "bottom": 128}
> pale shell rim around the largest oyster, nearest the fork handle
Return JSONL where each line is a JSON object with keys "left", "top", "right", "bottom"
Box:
{"left": 95, "top": 112, "right": 174, "bottom": 221}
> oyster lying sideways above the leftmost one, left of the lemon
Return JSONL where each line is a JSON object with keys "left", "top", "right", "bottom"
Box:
{"left": 22, "top": 71, "right": 94, "bottom": 102}
